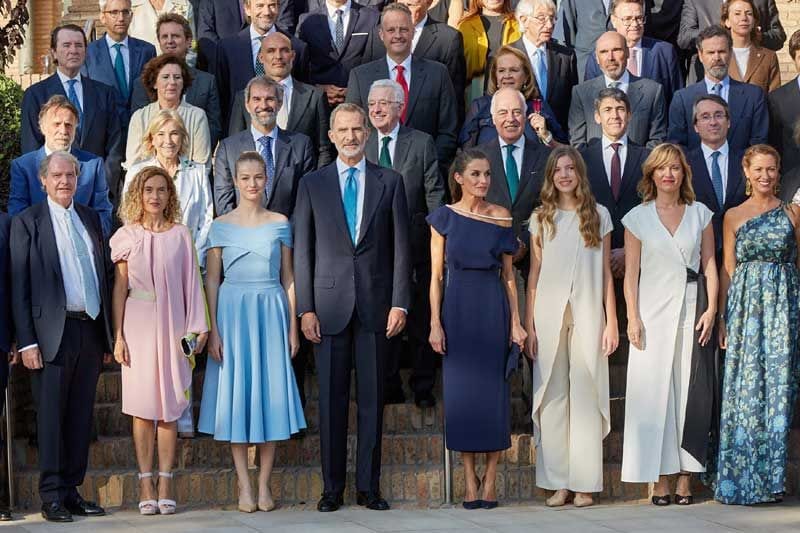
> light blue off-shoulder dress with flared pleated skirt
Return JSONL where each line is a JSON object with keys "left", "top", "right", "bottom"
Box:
{"left": 197, "top": 221, "right": 306, "bottom": 444}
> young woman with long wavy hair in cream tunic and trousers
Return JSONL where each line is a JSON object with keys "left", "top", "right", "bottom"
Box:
{"left": 525, "top": 146, "right": 619, "bottom": 507}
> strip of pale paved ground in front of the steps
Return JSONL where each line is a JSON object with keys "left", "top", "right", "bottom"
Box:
{"left": 0, "top": 499, "right": 800, "bottom": 533}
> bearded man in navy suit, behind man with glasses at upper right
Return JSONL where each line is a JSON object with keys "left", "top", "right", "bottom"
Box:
{"left": 667, "top": 26, "right": 769, "bottom": 152}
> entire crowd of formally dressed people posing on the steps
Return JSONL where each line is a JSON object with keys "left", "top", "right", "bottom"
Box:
{"left": 0, "top": 0, "right": 800, "bottom": 522}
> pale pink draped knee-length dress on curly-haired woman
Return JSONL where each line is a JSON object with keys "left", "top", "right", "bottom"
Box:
{"left": 110, "top": 224, "right": 208, "bottom": 422}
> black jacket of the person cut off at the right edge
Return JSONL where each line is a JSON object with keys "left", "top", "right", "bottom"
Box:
{"left": 767, "top": 78, "right": 800, "bottom": 170}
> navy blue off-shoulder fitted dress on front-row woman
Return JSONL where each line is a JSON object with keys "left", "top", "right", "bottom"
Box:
{"left": 427, "top": 206, "right": 517, "bottom": 452}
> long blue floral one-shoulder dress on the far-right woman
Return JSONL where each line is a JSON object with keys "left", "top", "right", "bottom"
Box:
{"left": 714, "top": 206, "right": 800, "bottom": 504}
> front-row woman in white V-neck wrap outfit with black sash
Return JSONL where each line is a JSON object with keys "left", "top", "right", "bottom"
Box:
{"left": 622, "top": 143, "right": 718, "bottom": 505}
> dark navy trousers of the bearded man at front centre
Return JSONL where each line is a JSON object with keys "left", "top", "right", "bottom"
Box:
{"left": 314, "top": 311, "right": 387, "bottom": 494}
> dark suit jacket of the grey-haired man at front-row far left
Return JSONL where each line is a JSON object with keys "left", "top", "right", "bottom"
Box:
{"left": 11, "top": 202, "right": 114, "bottom": 362}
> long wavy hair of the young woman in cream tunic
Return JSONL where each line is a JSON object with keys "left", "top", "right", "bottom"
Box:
{"left": 535, "top": 146, "right": 602, "bottom": 248}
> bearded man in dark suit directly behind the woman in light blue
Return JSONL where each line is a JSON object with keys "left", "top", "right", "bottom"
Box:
{"left": 214, "top": 76, "right": 316, "bottom": 217}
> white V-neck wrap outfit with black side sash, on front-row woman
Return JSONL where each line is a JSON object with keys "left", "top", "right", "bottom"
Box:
{"left": 622, "top": 202, "right": 712, "bottom": 483}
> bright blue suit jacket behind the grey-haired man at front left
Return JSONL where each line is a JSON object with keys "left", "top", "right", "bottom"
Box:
{"left": 8, "top": 146, "right": 113, "bottom": 237}
